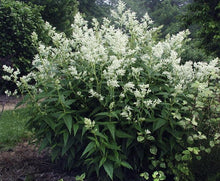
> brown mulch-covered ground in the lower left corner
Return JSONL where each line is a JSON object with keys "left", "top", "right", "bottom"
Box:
{"left": 0, "top": 142, "right": 75, "bottom": 181}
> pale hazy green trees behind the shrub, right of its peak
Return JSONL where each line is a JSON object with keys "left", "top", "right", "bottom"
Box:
{"left": 124, "top": 0, "right": 190, "bottom": 37}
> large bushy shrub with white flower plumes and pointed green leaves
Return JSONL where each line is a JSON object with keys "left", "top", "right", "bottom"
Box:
{"left": 4, "top": 2, "right": 220, "bottom": 181}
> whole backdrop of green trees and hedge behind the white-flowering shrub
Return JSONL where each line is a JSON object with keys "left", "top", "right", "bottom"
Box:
{"left": 0, "top": 0, "right": 220, "bottom": 93}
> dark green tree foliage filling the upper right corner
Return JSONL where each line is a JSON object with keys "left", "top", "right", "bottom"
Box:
{"left": 184, "top": 0, "right": 220, "bottom": 57}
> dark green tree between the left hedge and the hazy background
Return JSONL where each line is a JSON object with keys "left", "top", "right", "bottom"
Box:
{"left": 19, "top": 0, "right": 78, "bottom": 35}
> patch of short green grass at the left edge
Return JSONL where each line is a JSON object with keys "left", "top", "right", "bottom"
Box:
{"left": 0, "top": 108, "right": 31, "bottom": 150}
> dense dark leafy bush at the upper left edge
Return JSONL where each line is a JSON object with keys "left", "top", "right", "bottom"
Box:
{"left": 0, "top": 0, "right": 47, "bottom": 92}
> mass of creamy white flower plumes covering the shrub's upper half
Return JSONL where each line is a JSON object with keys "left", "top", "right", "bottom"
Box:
{"left": 3, "top": 1, "right": 220, "bottom": 129}
